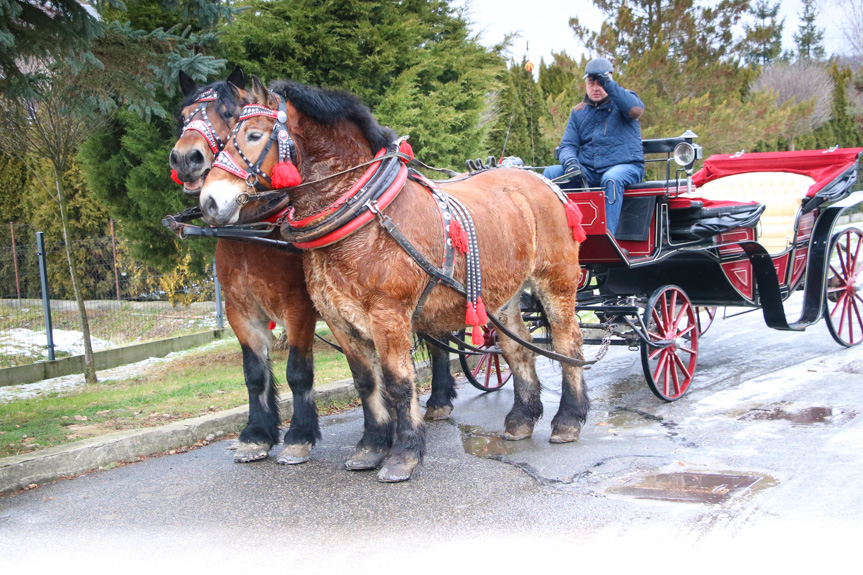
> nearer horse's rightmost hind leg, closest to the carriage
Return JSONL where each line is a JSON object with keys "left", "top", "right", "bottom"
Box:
{"left": 537, "top": 281, "right": 590, "bottom": 443}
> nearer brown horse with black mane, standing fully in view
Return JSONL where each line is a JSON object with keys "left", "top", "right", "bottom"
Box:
{"left": 200, "top": 77, "right": 589, "bottom": 482}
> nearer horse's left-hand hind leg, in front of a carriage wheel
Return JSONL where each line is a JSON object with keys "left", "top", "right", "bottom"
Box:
{"left": 490, "top": 291, "right": 542, "bottom": 441}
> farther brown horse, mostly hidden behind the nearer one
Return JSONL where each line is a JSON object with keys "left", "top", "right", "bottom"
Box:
{"left": 170, "top": 68, "right": 455, "bottom": 464}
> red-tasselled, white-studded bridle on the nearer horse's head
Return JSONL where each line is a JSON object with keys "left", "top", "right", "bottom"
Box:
{"left": 213, "top": 95, "right": 297, "bottom": 205}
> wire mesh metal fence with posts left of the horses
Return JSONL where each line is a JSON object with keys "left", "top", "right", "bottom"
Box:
{"left": 0, "top": 223, "right": 222, "bottom": 367}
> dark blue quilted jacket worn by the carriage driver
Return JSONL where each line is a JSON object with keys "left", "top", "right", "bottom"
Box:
{"left": 560, "top": 80, "right": 644, "bottom": 172}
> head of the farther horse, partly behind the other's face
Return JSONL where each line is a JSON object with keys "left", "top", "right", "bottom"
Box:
{"left": 170, "top": 66, "right": 249, "bottom": 197}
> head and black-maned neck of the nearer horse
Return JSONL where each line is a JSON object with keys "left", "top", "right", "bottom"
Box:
{"left": 199, "top": 76, "right": 395, "bottom": 225}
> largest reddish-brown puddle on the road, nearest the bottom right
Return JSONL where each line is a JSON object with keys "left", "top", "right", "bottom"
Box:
{"left": 608, "top": 473, "right": 776, "bottom": 505}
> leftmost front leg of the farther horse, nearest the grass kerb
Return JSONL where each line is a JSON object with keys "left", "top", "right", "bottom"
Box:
{"left": 225, "top": 306, "right": 279, "bottom": 463}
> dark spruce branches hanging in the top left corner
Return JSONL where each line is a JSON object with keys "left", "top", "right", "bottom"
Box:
{"left": 0, "top": 0, "right": 234, "bottom": 115}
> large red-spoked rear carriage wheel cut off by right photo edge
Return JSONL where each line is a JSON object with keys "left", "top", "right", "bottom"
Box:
{"left": 824, "top": 228, "right": 863, "bottom": 347}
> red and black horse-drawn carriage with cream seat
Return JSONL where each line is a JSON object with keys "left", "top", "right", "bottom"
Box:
{"left": 460, "top": 137, "right": 863, "bottom": 401}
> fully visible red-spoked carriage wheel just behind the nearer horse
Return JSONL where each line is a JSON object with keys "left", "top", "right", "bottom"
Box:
{"left": 641, "top": 285, "right": 698, "bottom": 401}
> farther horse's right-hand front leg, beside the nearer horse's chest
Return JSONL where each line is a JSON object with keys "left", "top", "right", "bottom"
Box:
{"left": 276, "top": 300, "right": 321, "bottom": 465}
